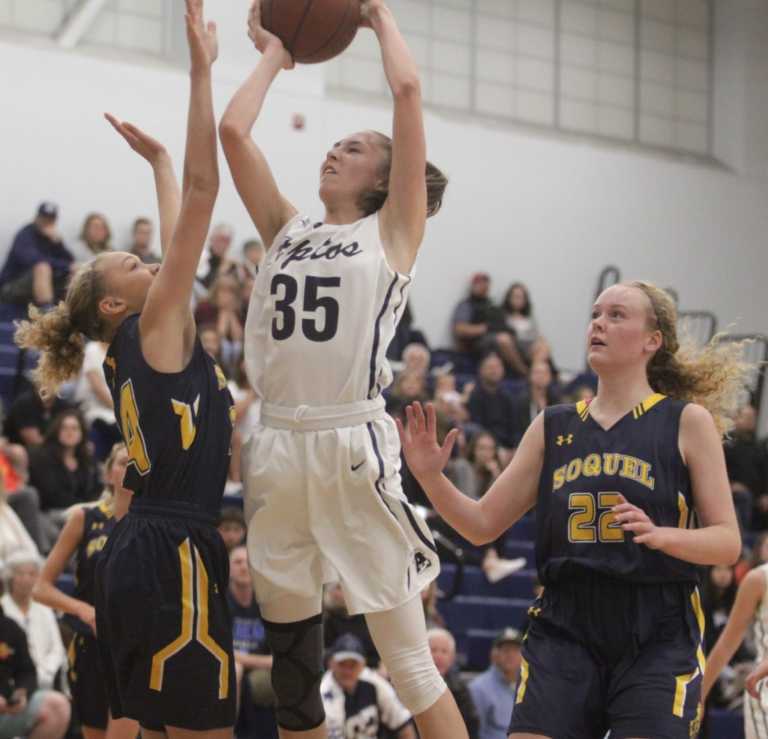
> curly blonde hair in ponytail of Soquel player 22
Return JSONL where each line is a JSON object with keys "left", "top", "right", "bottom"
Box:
{"left": 624, "top": 280, "right": 754, "bottom": 434}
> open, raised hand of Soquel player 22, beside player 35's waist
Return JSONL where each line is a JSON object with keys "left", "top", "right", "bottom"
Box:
{"left": 396, "top": 401, "right": 459, "bottom": 479}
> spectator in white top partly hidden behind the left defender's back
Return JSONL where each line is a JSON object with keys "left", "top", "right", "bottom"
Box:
{"left": 75, "top": 341, "right": 122, "bottom": 462}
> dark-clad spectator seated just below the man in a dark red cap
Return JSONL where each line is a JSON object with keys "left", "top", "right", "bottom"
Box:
{"left": 467, "top": 354, "right": 517, "bottom": 450}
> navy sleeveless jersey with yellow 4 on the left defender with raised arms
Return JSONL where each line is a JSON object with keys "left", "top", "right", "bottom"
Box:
{"left": 104, "top": 315, "right": 234, "bottom": 516}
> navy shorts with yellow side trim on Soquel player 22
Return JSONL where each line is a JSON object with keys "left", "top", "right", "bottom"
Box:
{"left": 509, "top": 574, "right": 705, "bottom": 739}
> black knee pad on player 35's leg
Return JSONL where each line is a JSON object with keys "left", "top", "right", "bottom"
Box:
{"left": 264, "top": 614, "right": 325, "bottom": 731}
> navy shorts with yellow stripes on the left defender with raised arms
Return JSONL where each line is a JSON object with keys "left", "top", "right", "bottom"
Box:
{"left": 96, "top": 501, "right": 235, "bottom": 731}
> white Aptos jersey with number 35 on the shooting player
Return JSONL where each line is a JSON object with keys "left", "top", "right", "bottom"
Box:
{"left": 245, "top": 214, "right": 411, "bottom": 407}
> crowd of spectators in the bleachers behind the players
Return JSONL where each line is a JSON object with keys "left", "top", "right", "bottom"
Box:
{"left": 0, "top": 202, "right": 768, "bottom": 739}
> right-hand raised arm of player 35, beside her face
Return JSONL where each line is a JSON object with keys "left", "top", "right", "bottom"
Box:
{"left": 362, "top": 0, "right": 427, "bottom": 272}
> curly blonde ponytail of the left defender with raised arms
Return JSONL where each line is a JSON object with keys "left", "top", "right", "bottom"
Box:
{"left": 14, "top": 258, "right": 112, "bottom": 397}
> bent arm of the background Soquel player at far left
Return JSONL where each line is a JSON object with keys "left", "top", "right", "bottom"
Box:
{"left": 32, "top": 508, "right": 96, "bottom": 631}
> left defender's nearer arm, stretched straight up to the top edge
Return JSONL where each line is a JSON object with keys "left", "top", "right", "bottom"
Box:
{"left": 140, "top": 0, "right": 219, "bottom": 372}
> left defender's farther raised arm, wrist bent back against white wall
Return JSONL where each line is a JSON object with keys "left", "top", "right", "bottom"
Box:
{"left": 104, "top": 113, "right": 181, "bottom": 256}
